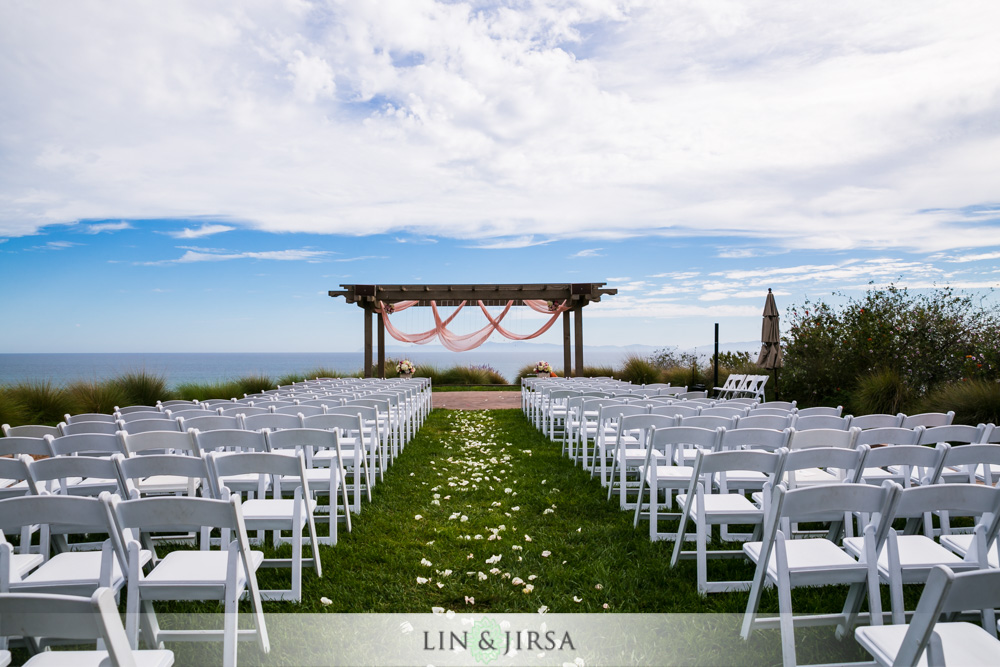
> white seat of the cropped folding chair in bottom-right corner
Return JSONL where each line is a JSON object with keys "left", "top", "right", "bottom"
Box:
{"left": 854, "top": 623, "right": 1000, "bottom": 667}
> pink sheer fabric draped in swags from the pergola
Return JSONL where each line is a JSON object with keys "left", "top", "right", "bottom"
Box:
{"left": 376, "top": 300, "right": 569, "bottom": 352}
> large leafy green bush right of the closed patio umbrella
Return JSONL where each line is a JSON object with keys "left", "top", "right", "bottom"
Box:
{"left": 781, "top": 285, "right": 1000, "bottom": 414}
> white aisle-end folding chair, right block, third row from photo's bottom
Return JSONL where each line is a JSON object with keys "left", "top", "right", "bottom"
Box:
{"left": 670, "top": 448, "right": 788, "bottom": 595}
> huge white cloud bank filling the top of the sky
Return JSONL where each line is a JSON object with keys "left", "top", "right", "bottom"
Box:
{"left": 0, "top": 0, "right": 1000, "bottom": 255}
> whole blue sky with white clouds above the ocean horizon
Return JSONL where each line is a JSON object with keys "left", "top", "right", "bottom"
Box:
{"left": 0, "top": 0, "right": 1000, "bottom": 352}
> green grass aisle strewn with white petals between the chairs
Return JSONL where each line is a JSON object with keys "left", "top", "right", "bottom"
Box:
{"left": 146, "top": 410, "right": 866, "bottom": 665}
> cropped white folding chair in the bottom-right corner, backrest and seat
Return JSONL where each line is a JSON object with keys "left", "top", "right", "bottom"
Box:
{"left": 854, "top": 565, "right": 1000, "bottom": 667}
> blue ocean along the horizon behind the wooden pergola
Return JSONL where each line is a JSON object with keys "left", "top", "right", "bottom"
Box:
{"left": 0, "top": 348, "right": 624, "bottom": 387}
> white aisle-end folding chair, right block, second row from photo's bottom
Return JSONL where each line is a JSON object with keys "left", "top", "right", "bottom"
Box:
{"left": 740, "top": 482, "right": 899, "bottom": 667}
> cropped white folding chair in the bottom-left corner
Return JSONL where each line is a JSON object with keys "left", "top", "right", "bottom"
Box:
{"left": 0, "top": 588, "right": 174, "bottom": 667}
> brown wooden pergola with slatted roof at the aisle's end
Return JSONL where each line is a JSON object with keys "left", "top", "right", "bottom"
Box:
{"left": 329, "top": 283, "right": 618, "bottom": 377}
